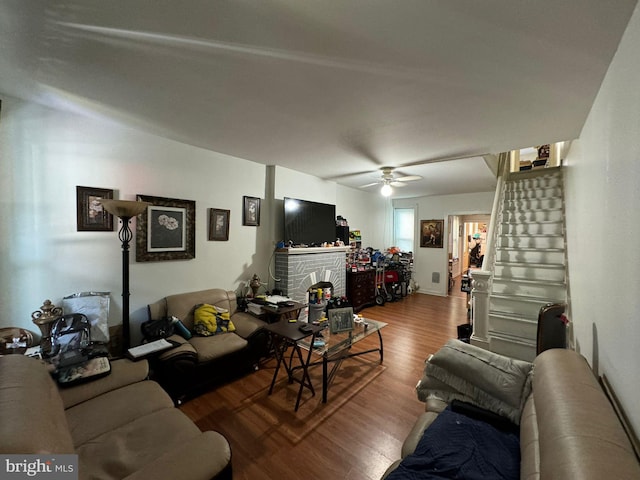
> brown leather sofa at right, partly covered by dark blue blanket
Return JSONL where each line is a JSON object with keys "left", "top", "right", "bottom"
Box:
{"left": 382, "top": 340, "right": 640, "bottom": 480}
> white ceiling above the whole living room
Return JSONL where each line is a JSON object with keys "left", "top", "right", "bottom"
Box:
{"left": 0, "top": 0, "right": 636, "bottom": 197}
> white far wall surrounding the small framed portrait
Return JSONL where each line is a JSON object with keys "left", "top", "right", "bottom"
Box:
{"left": 393, "top": 192, "right": 494, "bottom": 296}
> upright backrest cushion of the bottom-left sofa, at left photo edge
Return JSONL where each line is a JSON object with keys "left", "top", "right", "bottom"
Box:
{"left": 0, "top": 354, "right": 74, "bottom": 454}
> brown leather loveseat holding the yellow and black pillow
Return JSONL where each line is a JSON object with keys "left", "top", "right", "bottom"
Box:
{"left": 148, "top": 288, "right": 269, "bottom": 402}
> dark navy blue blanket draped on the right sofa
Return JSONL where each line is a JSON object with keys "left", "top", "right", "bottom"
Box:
{"left": 387, "top": 409, "right": 520, "bottom": 480}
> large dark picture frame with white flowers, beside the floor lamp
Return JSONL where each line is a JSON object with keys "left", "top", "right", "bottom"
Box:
{"left": 136, "top": 195, "right": 196, "bottom": 262}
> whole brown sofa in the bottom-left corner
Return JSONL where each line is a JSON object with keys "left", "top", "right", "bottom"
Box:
{"left": 0, "top": 355, "right": 232, "bottom": 480}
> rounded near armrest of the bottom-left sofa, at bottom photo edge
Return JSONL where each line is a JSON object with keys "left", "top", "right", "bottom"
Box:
{"left": 121, "top": 431, "right": 231, "bottom": 480}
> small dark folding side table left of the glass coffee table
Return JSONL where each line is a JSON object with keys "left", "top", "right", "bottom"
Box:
{"left": 264, "top": 319, "right": 323, "bottom": 412}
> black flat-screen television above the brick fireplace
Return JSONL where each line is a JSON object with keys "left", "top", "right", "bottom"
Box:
{"left": 284, "top": 197, "right": 336, "bottom": 247}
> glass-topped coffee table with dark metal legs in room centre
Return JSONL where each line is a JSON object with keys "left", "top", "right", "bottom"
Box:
{"left": 298, "top": 318, "right": 387, "bottom": 403}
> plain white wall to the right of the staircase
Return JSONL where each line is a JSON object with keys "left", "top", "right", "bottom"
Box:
{"left": 564, "top": 0, "right": 640, "bottom": 433}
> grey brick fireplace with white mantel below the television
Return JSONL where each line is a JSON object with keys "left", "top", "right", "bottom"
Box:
{"left": 275, "top": 247, "right": 348, "bottom": 303}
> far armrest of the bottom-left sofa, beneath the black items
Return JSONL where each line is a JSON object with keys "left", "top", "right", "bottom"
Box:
{"left": 59, "top": 358, "right": 149, "bottom": 409}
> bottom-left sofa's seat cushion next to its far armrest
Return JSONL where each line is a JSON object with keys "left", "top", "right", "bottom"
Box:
{"left": 67, "top": 380, "right": 174, "bottom": 446}
